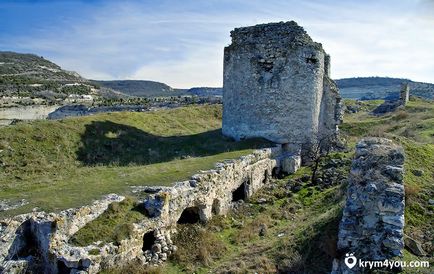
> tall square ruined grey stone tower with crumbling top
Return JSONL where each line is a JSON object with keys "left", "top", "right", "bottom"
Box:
{"left": 223, "top": 21, "right": 342, "bottom": 156}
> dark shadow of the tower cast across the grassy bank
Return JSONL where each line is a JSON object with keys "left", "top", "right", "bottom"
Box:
{"left": 77, "top": 121, "right": 271, "bottom": 166}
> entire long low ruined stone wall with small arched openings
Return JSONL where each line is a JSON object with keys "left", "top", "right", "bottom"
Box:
{"left": 0, "top": 146, "right": 301, "bottom": 273}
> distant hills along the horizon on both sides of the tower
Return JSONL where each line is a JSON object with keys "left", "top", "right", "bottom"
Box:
{"left": 0, "top": 51, "right": 434, "bottom": 100}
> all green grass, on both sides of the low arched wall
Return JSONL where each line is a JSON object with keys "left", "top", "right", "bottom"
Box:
{"left": 0, "top": 99, "right": 434, "bottom": 273}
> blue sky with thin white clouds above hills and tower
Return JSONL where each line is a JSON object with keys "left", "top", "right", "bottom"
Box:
{"left": 0, "top": 0, "right": 434, "bottom": 88}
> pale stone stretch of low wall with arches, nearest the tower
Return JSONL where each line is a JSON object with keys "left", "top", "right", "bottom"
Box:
{"left": 144, "top": 147, "right": 286, "bottom": 223}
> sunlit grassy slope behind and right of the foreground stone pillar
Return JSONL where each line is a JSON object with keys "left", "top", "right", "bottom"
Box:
{"left": 342, "top": 98, "right": 434, "bottom": 265}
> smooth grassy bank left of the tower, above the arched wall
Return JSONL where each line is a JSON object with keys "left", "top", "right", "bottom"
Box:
{"left": 0, "top": 105, "right": 265, "bottom": 216}
